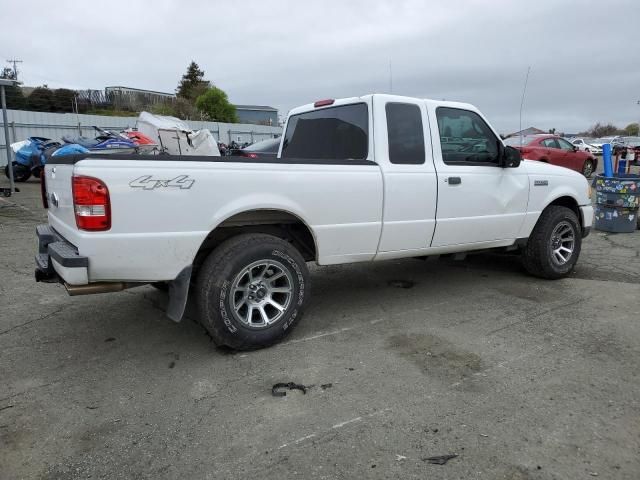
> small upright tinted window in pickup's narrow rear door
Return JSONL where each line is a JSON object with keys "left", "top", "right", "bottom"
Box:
{"left": 385, "top": 103, "right": 424, "bottom": 164}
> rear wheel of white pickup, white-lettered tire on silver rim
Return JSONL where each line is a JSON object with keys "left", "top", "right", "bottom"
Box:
{"left": 196, "top": 234, "right": 309, "bottom": 350}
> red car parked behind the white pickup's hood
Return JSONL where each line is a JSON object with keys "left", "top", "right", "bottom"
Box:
{"left": 504, "top": 135, "right": 598, "bottom": 178}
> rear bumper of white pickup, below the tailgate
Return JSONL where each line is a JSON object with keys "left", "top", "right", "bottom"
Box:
{"left": 35, "top": 225, "right": 89, "bottom": 285}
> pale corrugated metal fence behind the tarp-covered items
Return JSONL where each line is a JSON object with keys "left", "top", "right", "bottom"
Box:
{"left": 0, "top": 110, "right": 282, "bottom": 165}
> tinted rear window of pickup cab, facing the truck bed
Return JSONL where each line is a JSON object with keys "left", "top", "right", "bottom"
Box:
{"left": 282, "top": 103, "right": 369, "bottom": 160}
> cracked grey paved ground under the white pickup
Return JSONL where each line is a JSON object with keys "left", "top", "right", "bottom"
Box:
{"left": 0, "top": 182, "right": 640, "bottom": 480}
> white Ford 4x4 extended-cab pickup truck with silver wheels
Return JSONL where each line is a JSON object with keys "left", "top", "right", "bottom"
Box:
{"left": 36, "top": 94, "right": 593, "bottom": 349}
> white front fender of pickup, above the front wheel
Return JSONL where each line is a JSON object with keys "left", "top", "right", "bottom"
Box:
{"left": 522, "top": 160, "right": 591, "bottom": 205}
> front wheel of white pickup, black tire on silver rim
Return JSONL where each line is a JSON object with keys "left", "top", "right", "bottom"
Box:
{"left": 522, "top": 205, "right": 582, "bottom": 280}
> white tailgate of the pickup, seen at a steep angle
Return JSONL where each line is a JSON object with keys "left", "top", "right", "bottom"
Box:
{"left": 44, "top": 164, "right": 76, "bottom": 229}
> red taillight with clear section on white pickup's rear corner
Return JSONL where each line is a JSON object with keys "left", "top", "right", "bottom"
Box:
{"left": 72, "top": 176, "right": 111, "bottom": 232}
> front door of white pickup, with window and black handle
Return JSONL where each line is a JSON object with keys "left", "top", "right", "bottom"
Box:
{"left": 429, "top": 107, "right": 529, "bottom": 247}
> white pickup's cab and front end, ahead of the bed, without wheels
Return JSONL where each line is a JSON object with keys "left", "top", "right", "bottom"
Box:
{"left": 279, "top": 95, "right": 592, "bottom": 260}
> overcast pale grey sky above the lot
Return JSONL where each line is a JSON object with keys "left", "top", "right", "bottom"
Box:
{"left": 0, "top": 0, "right": 640, "bottom": 132}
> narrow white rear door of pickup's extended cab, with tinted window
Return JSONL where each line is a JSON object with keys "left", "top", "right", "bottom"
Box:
{"left": 374, "top": 95, "right": 437, "bottom": 253}
